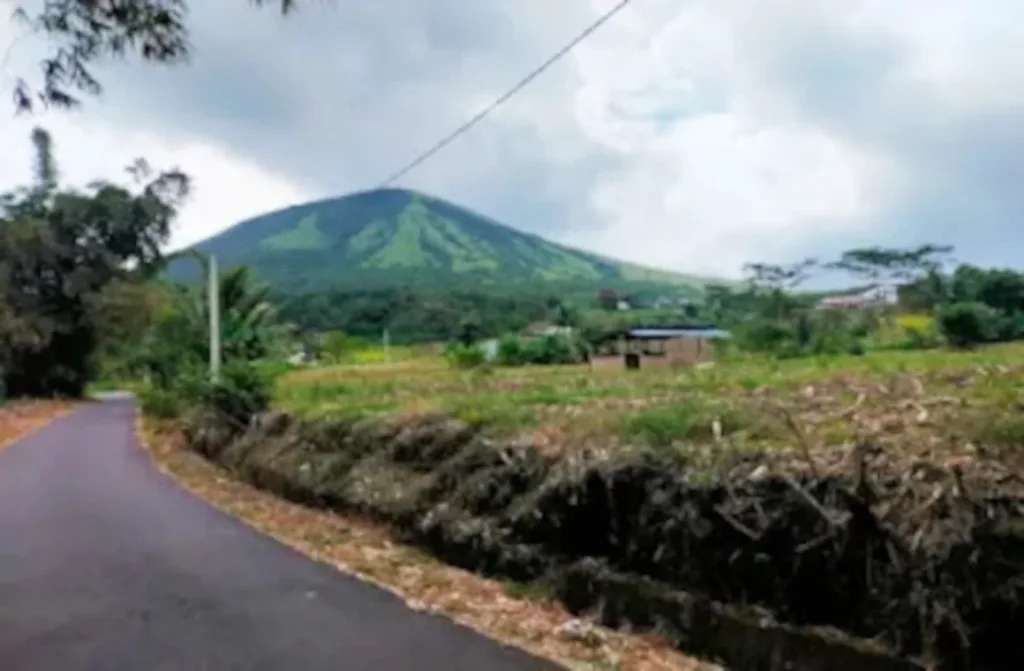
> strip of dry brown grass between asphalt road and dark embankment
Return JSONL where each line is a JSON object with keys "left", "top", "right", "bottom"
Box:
{"left": 139, "top": 421, "right": 715, "bottom": 671}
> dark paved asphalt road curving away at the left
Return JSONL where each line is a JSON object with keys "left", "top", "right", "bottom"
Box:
{"left": 0, "top": 400, "right": 553, "bottom": 671}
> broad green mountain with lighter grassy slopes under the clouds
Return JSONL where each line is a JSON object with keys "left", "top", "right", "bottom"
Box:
{"left": 171, "top": 188, "right": 709, "bottom": 293}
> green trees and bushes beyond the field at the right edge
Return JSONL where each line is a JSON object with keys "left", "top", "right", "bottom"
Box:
{"left": 701, "top": 244, "right": 1024, "bottom": 355}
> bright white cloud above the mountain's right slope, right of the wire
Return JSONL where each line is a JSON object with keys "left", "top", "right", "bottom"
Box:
{"left": 578, "top": 2, "right": 892, "bottom": 272}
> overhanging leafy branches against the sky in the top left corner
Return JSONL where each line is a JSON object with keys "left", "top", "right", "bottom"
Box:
{"left": 14, "top": 0, "right": 296, "bottom": 111}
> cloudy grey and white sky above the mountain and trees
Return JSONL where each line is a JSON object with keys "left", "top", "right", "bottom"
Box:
{"left": 0, "top": 0, "right": 1024, "bottom": 275}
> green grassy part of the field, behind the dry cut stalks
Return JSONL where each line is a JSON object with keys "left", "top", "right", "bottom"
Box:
{"left": 275, "top": 344, "right": 1024, "bottom": 443}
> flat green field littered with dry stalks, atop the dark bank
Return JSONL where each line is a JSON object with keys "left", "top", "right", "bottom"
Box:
{"left": 278, "top": 344, "right": 1024, "bottom": 458}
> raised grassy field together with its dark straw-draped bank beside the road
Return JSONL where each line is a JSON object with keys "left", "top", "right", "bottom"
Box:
{"left": 186, "top": 346, "right": 1024, "bottom": 670}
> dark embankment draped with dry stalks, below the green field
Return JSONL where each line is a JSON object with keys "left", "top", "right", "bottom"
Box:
{"left": 186, "top": 414, "right": 1024, "bottom": 671}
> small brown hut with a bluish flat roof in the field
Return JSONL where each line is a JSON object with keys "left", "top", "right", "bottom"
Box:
{"left": 590, "top": 327, "right": 729, "bottom": 370}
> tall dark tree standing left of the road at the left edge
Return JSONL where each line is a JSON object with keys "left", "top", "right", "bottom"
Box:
{"left": 0, "top": 130, "right": 188, "bottom": 396}
